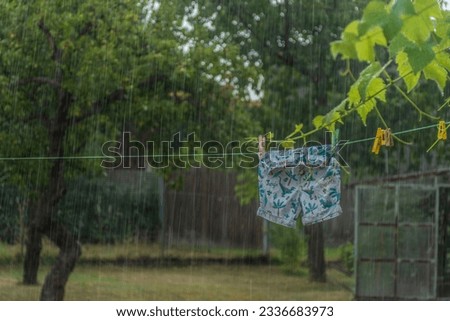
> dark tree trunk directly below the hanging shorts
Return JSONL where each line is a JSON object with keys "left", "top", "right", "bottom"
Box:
{"left": 305, "top": 223, "right": 327, "bottom": 282}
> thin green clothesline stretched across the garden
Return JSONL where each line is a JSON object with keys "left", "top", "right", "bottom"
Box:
{"left": 0, "top": 121, "right": 450, "bottom": 161}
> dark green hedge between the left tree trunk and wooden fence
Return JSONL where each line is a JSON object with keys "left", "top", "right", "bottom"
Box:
{"left": 58, "top": 175, "right": 160, "bottom": 243}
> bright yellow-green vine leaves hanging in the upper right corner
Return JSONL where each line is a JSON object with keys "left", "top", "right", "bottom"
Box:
{"left": 324, "top": 0, "right": 450, "bottom": 128}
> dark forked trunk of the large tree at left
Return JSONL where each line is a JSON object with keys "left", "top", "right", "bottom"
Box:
{"left": 24, "top": 85, "right": 81, "bottom": 300}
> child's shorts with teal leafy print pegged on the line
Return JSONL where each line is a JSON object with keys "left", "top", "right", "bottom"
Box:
{"left": 257, "top": 145, "right": 342, "bottom": 227}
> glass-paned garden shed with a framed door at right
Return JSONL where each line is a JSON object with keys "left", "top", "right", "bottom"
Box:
{"left": 355, "top": 169, "right": 450, "bottom": 300}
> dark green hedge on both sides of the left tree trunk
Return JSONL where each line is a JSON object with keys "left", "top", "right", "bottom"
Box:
{"left": 0, "top": 175, "right": 161, "bottom": 244}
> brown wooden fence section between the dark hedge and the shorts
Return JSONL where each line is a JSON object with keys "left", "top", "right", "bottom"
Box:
{"left": 162, "top": 168, "right": 263, "bottom": 248}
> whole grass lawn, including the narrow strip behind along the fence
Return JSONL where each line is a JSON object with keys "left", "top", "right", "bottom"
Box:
{"left": 0, "top": 244, "right": 354, "bottom": 301}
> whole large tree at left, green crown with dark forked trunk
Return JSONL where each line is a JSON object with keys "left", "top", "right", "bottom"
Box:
{"left": 0, "top": 0, "right": 258, "bottom": 300}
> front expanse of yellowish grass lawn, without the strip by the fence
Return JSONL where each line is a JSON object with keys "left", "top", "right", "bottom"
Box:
{"left": 0, "top": 265, "right": 352, "bottom": 301}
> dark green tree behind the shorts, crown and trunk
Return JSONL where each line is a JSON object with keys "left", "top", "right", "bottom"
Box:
{"left": 199, "top": 0, "right": 367, "bottom": 281}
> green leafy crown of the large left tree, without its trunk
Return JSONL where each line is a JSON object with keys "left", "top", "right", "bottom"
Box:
{"left": 0, "top": 0, "right": 259, "bottom": 195}
